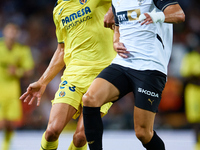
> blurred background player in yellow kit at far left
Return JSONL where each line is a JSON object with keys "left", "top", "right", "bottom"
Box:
{"left": 0, "top": 23, "right": 34, "bottom": 150}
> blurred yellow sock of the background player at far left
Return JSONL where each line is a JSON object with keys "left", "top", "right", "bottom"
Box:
{"left": 1, "top": 131, "right": 14, "bottom": 150}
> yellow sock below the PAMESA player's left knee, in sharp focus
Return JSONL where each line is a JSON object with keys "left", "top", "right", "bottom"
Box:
{"left": 40, "top": 132, "right": 58, "bottom": 150}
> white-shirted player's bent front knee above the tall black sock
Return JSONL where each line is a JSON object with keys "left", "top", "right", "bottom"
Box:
{"left": 82, "top": 92, "right": 100, "bottom": 107}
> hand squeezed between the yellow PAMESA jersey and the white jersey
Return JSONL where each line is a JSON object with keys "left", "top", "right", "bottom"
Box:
{"left": 104, "top": 7, "right": 115, "bottom": 30}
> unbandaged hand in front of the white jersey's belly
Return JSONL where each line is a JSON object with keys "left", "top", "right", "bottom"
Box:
{"left": 113, "top": 42, "right": 130, "bottom": 58}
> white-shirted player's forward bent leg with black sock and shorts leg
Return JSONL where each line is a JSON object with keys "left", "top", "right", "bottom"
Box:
{"left": 82, "top": 65, "right": 130, "bottom": 150}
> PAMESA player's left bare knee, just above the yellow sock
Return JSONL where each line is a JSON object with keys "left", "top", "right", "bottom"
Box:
{"left": 45, "top": 128, "right": 60, "bottom": 142}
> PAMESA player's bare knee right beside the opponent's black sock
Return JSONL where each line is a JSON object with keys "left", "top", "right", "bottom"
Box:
{"left": 73, "top": 132, "right": 86, "bottom": 147}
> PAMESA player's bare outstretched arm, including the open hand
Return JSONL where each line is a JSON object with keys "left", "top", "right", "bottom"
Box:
{"left": 20, "top": 43, "right": 65, "bottom": 106}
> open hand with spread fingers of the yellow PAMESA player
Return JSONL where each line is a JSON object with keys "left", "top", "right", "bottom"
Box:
{"left": 20, "top": 82, "right": 46, "bottom": 106}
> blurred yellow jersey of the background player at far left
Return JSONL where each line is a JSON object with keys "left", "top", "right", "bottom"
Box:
{"left": 0, "top": 38, "right": 34, "bottom": 101}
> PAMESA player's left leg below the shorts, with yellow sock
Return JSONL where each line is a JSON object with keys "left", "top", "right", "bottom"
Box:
{"left": 40, "top": 103, "right": 77, "bottom": 150}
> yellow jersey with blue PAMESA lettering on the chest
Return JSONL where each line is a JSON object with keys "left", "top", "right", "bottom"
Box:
{"left": 53, "top": 0, "right": 116, "bottom": 85}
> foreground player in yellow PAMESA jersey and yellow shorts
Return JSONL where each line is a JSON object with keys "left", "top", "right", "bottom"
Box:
{"left": 20, "top": 0, "right": 116, "bottom": 150}
